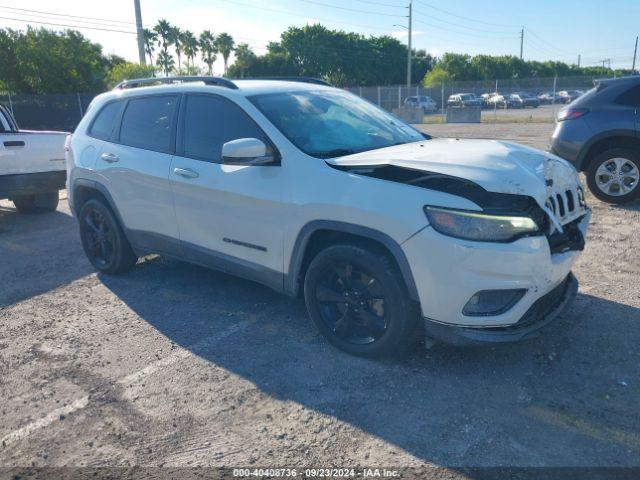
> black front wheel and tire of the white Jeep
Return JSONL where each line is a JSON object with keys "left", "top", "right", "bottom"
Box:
{"left": 304, "top": 245, "right": 417, "bottom": 357}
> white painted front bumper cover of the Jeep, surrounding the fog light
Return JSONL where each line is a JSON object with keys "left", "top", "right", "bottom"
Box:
{"left": 402, "top": 210, "right": 591, "bottom": 329}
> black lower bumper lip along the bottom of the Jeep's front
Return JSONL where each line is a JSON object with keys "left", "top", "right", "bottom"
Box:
{"left": 424, "top": 273, "right": 578, "bottom": 346}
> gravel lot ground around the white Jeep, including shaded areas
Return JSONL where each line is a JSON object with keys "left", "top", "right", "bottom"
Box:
{"left": 0, "top": 124, "right": 640, "bottom": 478}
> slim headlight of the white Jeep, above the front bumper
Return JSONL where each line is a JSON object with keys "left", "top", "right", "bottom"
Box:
{"left": 424, "top": 206, "right": 540, "bottom": 242}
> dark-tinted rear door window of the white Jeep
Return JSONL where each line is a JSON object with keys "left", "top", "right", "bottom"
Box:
{"left": 120, "top": 95, "right": 178, "bottom": 152}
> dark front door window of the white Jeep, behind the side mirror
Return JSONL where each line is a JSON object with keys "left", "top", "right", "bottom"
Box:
{"left": 182, "top": 95, "right": 269, "bottom": 163}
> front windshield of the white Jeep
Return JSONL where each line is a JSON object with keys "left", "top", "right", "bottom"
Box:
{"left": 249, "top": 90, "right": 428, "bottom": 158}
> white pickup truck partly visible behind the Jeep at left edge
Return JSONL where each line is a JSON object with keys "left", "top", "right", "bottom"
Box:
{"left": 0, "top": 105, "right": 68, "bottom": 213}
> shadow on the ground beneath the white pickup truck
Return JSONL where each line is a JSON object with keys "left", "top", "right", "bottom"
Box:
{"left": 0, "top": 202, "right": 94, "bottom": 307}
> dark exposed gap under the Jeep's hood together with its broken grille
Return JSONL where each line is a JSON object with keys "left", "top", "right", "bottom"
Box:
{"left": 327, "top": 162, "right": 589, "bottom": 254}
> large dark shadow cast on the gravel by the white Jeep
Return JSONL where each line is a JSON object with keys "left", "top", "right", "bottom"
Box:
{"left": 99, "top": 258, "right": 640, "bottom": 468}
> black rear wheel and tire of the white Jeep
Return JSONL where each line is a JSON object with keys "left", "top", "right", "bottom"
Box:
{"left": 78, "top": 198, "right": 137, "bottom": 274}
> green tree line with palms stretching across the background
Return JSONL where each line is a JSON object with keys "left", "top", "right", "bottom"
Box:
{"left": 0, "top": 19, "right": 630, "bottom": 93}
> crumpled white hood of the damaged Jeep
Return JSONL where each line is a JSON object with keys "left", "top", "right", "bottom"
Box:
{"left": 327, "top": 138, "right": 580, "bottom": 210}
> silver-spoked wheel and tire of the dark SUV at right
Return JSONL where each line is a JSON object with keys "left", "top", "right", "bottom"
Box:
{"left": 587, "top": 148, "right": 640, "bottom": 204}
